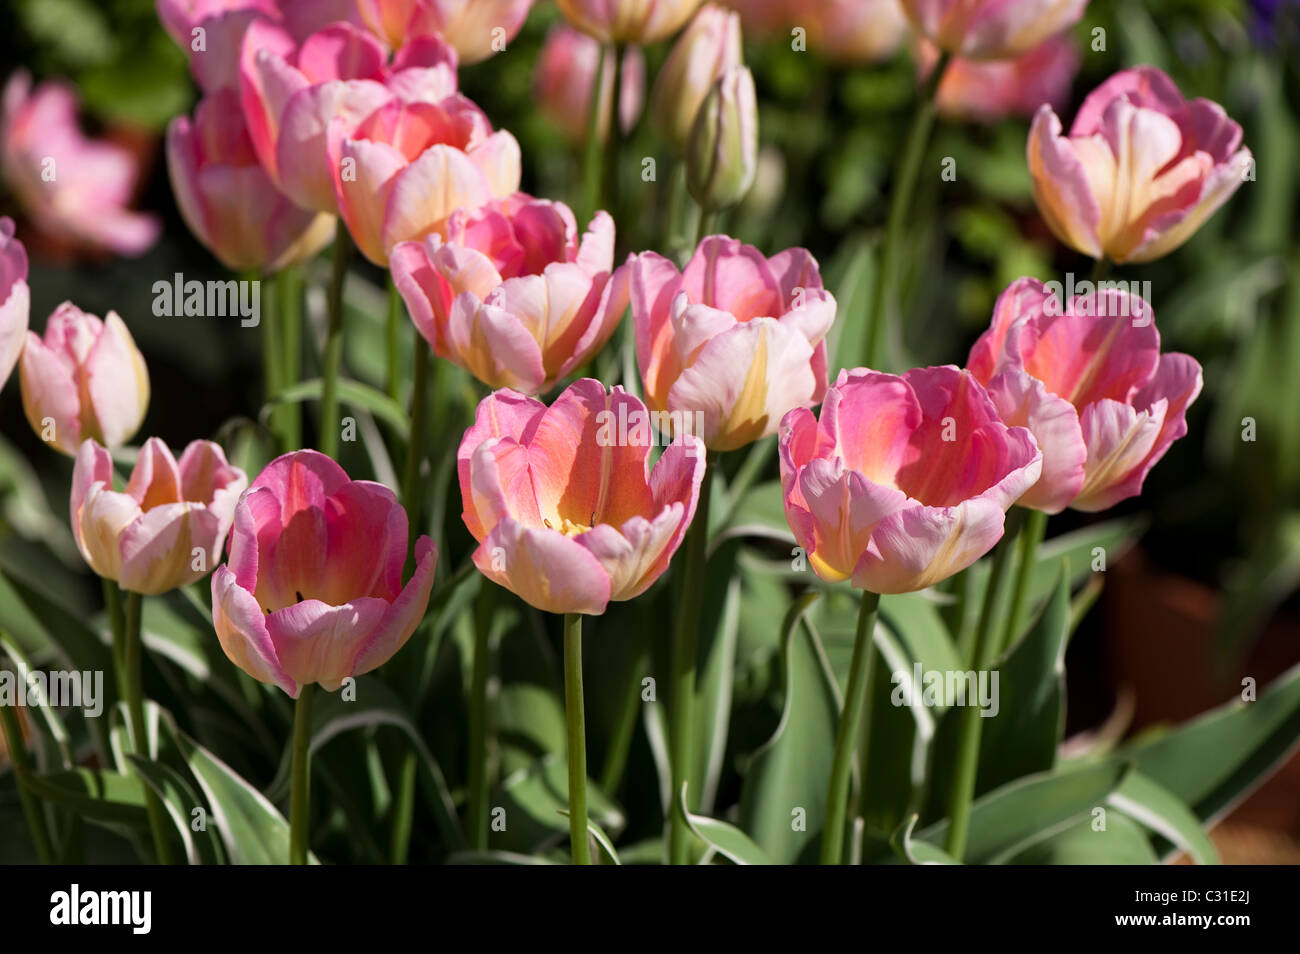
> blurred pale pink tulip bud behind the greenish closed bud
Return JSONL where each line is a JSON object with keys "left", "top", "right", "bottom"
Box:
{"left": 650, "top": 4, "right": 741, "bottom": 156}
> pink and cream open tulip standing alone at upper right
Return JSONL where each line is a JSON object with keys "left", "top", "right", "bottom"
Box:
{"left": 1028, "top": 66, "right": 1253, "bottom": 263}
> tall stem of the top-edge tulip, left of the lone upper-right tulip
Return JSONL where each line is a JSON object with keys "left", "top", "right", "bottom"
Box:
{"left": 862, "top": 53, "right": 948, "bottom": 370}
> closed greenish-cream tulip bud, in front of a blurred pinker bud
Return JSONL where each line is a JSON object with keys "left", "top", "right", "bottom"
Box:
{"left": 686, "top": 66, "right": 758, "bottom": 212}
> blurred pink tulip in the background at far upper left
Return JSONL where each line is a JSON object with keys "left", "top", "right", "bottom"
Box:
{"left": 0, "top": 70, "right": 160, "bottom": 256}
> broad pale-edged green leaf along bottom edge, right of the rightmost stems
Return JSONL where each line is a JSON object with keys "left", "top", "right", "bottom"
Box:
{"left": 919, "top": 763, "right": 1130, "bottom": 864}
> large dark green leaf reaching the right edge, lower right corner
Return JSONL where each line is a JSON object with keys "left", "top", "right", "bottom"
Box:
{"left": 1119, "top": 665, "right": 1300, "bottom": 824}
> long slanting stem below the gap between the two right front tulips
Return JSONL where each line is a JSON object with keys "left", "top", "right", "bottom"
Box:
{"left": 946, "top": 519, "right": 1021, "bottom": 862}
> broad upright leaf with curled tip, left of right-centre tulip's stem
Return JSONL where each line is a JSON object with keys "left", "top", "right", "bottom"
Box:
{"left": 740, "top": 593, "right": 840, "bottom": 864}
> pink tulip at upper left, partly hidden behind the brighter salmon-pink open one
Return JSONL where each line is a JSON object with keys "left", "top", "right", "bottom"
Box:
{"left": 239, "top": 19, "right": 456, "bottom": 212}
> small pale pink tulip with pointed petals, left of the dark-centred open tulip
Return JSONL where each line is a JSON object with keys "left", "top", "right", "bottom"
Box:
{"left": 72, "top": 437, "right": 248, "bottom": 595}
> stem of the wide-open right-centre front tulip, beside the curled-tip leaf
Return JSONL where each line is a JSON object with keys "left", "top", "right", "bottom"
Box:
{"left": 822, "top": 590, "right": 880, "bottom": 864}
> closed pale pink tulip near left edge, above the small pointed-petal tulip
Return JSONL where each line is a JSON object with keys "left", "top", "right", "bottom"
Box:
{"left": 18, "top": 302, "right": 150, "bottom": 456}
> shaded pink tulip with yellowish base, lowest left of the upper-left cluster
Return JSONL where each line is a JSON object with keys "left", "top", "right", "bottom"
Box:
{"left": 166, "top": 90, "right": 334, "bottom": 272}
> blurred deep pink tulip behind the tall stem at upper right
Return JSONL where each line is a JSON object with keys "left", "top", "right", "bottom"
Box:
{"left": 919, "top": 34, "right": 1079, "bottom": 122}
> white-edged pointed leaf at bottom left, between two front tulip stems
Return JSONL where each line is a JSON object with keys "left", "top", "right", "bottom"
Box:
{"left": 175, "top": 733, "right": 316, "bottom": 864}
